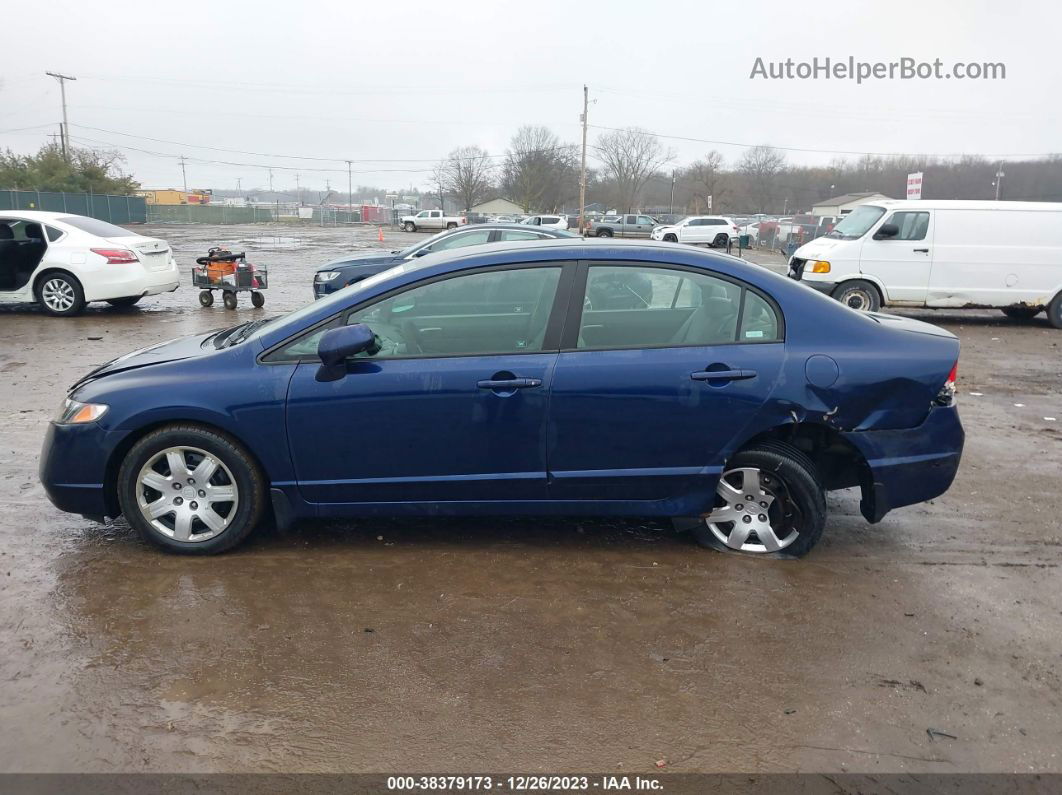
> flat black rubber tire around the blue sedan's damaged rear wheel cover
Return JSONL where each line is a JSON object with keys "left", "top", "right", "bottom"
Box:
{"left": 690, "top": 442, "right": 826, "bottom": 558}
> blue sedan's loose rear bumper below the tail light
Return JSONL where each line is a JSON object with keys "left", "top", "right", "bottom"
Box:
{"left": 842, "top": 405, "right": 965, "bottom": 522}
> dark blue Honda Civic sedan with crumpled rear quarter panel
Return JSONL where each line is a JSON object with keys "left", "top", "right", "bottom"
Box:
{"left": 40, "top": 239, "right": 963, "bottom": 556}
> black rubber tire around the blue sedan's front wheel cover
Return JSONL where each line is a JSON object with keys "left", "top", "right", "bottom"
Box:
{"left": 118, "top": 425, "right": 266, "bottom": 555}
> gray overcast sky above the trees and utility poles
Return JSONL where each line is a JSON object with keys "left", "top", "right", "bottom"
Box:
{"left": 0, "top": 0, "right": 1062, "bottom": 190}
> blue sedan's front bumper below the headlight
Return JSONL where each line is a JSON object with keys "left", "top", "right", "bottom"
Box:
{"left": 39, "top": 422, "right": 118, "bottom": 517}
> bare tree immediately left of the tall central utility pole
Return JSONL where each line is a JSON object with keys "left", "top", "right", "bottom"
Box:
{"left": 501, "top": 124, "right": 573, "bottom": 212}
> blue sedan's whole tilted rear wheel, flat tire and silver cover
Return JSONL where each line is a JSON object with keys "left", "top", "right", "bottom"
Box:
{"left": 692, "top": 442, "right": 826, "bottom": 557}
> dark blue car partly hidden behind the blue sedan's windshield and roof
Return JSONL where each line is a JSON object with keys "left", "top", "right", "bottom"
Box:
{"left": 313, "top": 223, "right": 579, "bottom": 298}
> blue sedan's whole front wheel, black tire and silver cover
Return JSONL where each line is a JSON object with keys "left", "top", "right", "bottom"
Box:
{"left": 118, "top": 425, "right": 266, "bottom": 555}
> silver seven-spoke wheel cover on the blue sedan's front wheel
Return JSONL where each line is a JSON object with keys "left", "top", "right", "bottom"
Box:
{"left": 136, "top": 447, "right": 239, "bottom": 543}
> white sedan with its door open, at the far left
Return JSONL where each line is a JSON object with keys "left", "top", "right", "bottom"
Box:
{"left": 0, "top": 210, "right": 179, "bottom": 315}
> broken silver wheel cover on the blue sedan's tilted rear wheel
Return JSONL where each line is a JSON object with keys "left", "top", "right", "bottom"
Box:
{"left": 704, "top": 467, "right": 801, "bottom": 553}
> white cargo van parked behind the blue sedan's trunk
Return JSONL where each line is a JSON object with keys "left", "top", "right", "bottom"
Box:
{"left": 789, "top": 201, "right": 1062, "bottom": 328}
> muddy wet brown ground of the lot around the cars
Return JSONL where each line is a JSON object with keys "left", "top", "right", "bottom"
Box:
{"left": 0, "top": 221, "right": 1062, "bottom": 773}
